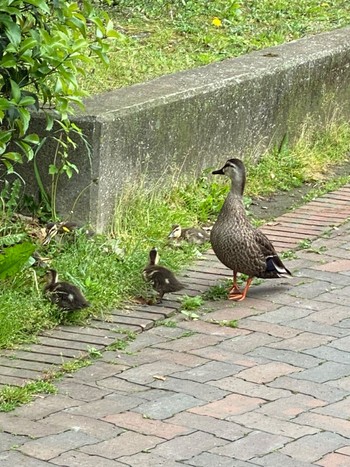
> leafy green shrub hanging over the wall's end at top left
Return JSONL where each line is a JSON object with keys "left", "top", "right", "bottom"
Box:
{"left": 0, "top": 0, "right": 120, "bottom": 212}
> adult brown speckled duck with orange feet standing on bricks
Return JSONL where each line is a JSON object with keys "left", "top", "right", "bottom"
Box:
{"left": 210, "top": 159, "right": 291, "bottom": 301}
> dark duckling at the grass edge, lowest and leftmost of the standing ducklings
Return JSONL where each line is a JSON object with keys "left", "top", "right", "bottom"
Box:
{"left": 44, "top": 269, "right": 90, "bottom": 311}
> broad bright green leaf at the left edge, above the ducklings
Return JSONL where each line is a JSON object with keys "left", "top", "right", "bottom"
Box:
{"left": 0, "top": 242, "right": 36, "bottom": 279}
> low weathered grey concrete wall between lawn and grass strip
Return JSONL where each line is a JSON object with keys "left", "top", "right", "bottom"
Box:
{"left": 18, "top": 28, "right": 350, "bottom": 231}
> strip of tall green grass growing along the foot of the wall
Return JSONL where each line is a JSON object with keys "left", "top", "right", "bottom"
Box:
{"left": 0, "top": 119, "right": 350, "bottom": 348}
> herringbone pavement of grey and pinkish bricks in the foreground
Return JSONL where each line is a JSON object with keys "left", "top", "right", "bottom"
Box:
{"left": 0, "top": 189, "right": 350, "bottom": 467}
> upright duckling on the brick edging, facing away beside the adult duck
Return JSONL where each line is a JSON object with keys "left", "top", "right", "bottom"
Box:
{"left": 142, "top": 247, "right": 185, "bottom": 303}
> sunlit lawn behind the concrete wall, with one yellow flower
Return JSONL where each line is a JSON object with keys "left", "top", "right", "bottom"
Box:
{"left": 82, "top": 0, "right": 350, "bottom": 93}
